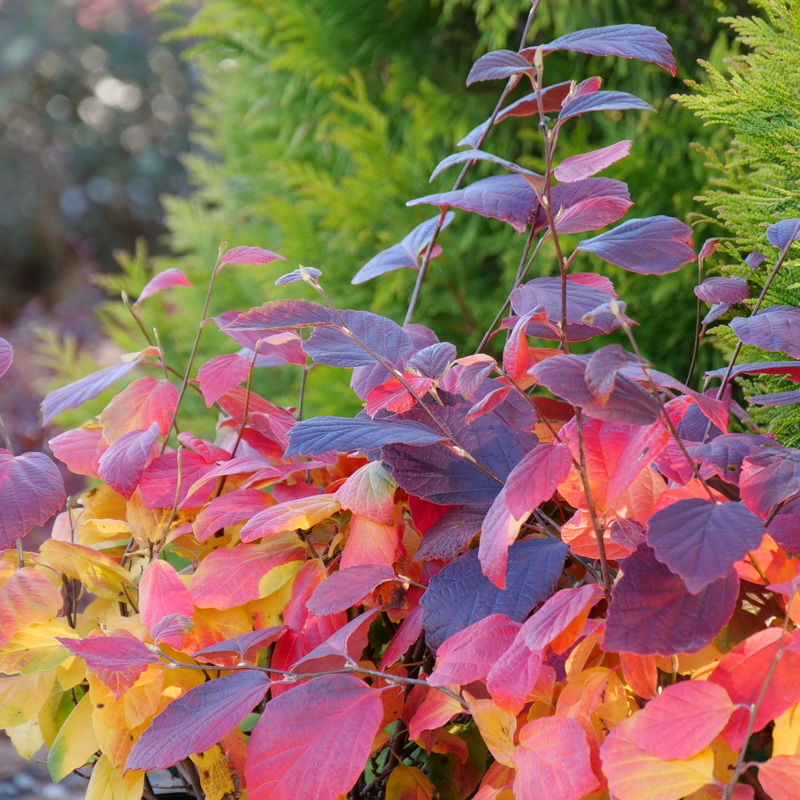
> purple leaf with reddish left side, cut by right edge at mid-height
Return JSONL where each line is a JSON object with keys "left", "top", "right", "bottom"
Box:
{"left": 739, "top": 447, "right": 800, "bottom": 519}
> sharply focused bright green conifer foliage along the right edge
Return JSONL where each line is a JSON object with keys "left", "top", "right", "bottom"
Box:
{"left": 676, "top": 0, "right": 800, "bottom": 447}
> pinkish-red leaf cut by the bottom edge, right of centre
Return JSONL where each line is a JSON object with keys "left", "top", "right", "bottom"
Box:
{"left": 513, "top": 717, "right": 598, "bottom": 800}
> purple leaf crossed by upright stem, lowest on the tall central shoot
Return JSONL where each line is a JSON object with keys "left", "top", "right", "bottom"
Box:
{"left": 506, "top": 274, "right": 633, "bottom": 342}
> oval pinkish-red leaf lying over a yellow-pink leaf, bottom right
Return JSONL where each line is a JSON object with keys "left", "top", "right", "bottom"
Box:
{"left": 630, "top": 681, "right": 736, "bottom": 761}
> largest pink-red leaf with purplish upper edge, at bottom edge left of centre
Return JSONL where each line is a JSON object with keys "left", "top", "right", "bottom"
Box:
{"left": 247, "top": 675, "right": 383, "bottom": 800}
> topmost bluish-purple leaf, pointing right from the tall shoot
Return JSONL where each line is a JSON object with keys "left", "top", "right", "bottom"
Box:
{"left": 536, "top": 25, "right": 677, "bottom": 77}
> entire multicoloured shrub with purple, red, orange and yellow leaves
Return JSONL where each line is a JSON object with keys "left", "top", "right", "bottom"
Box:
{"left": 0, "top": 3, "right": 800, "bottom": 800}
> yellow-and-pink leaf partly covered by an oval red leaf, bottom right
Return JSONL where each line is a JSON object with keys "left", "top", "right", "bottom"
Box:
{"left": 600, "top": 717, "right": 714, "bottom": 800}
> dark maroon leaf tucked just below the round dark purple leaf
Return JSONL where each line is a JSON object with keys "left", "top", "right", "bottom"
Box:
{"left": 602, "top": 544, "right": 739, "bottom": 656}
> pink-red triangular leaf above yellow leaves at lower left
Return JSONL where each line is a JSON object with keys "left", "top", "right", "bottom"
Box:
{"left": 56, "top": 636, "right": 159, "bottom": 700}
